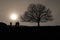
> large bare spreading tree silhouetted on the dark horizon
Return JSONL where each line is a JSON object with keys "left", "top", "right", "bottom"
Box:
{"left": 21, "top": 4, "right": 52, "bottom": 27}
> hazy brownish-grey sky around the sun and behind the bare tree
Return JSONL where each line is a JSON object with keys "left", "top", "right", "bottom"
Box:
{"left": 0, "top": 0, "right": 60, "bottom": 25}
